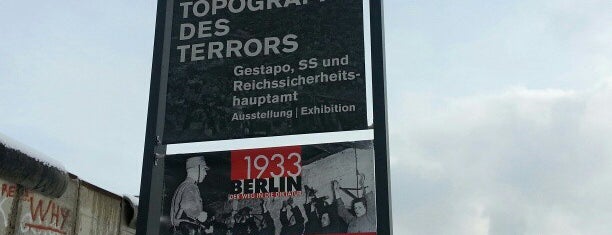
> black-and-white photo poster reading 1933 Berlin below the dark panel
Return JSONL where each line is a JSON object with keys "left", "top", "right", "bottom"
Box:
{"left": 160, "top": 141, "right": 377, "bottom": 235}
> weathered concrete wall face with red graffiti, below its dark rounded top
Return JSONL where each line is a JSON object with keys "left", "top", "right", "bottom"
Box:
{"left": 0, "top": 177, "right": 138, "bottom": 235}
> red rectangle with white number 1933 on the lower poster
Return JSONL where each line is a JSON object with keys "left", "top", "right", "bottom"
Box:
{"left": 232, "top": 146, "right": 302, "bottom": 180}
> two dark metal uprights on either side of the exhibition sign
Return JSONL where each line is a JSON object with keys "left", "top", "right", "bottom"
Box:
{"left": 136, "top": 0, "right": 393, "bottom": 235}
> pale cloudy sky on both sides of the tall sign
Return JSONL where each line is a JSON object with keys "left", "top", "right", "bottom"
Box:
{"left": 0, "top": 0, "right": 612, "bottom": 235}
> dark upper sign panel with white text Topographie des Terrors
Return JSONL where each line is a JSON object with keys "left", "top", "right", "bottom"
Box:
{"left": 163, "top": 0, "right": 367, "bottom": 144}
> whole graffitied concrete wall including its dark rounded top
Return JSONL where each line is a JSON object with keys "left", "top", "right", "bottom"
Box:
{"left": 0, "top": 130, "right": 138, "bottom": 235}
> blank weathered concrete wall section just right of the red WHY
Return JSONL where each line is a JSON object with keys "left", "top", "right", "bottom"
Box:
{"left": 76, "top": 183, "right": 122, "bottom": 235}
